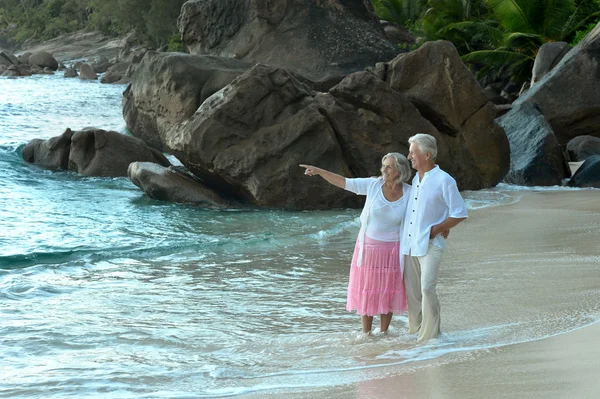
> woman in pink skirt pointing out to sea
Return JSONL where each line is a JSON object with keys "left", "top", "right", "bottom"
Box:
{"left": 300, "top": 152, "right": 411, "bottom": 334}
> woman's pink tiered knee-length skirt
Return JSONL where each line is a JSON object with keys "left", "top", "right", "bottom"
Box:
{"left": 346, "top": 235, "right": 406, "bottom": 316}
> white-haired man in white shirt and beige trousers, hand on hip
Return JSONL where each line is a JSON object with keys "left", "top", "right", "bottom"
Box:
{"left": 401, "top": 133, "right": 467, "bottom": 341}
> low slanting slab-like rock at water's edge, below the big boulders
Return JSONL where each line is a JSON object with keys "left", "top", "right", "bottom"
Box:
{"left": 127, "top": 162, "right": 232, "bottom": 207}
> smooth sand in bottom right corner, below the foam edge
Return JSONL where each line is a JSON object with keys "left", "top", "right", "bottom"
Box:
{"left": 304, "top": 320, "right": 600, "bottom": 399}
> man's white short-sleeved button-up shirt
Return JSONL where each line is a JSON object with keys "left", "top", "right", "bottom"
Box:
{"left": 401, "top": 165, "right": 468, "bottom": 256}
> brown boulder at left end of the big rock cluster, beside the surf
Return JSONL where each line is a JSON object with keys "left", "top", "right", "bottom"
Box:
{"left": 123, "top": 52, "right": 250, "bottom": 149}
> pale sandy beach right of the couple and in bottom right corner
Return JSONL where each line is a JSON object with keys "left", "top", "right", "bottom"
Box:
{"left": 248, "top": 191, "right": 600, "bottom": 399}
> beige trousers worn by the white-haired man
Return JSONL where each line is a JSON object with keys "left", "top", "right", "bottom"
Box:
{"left": 404, "top": 243, "right": 444, "bottom": 341}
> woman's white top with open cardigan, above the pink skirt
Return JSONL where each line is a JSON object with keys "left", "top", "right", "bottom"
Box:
{"left": 345, "top": 177, "right": 410, "bottom": 270}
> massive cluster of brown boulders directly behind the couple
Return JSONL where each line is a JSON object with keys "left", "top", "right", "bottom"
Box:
{"left": 124, "top": 42, "right": 510, "bottom": 209}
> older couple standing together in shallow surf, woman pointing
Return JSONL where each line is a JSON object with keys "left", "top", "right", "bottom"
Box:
{"left": 300, "top": 133, "right": 467, "bottom": 341}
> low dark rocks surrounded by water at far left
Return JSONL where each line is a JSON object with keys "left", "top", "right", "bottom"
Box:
{"left": 23, "top": 129, "right": 171, "bottom": 176}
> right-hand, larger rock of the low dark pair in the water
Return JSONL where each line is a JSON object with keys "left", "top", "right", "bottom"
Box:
{"left": 69, "top": 129, "right": 171, "bottom": 177}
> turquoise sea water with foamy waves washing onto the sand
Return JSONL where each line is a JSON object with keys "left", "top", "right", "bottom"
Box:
{"left": 0, "top": 74, "right": 600, "bottom": 398}
